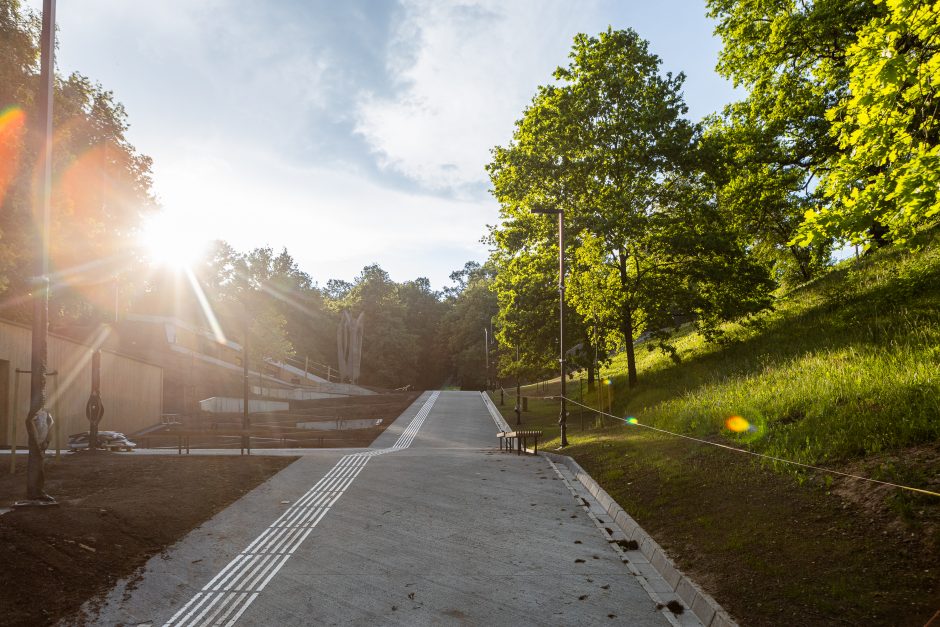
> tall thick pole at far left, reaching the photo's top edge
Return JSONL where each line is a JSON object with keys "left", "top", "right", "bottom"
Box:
{"left": 26, "top": 0, "right": 55, "bottom": 503}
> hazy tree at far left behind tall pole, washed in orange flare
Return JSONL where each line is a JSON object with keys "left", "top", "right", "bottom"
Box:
{"left": 0, "top": 0, "right": 155, "bottom": 324}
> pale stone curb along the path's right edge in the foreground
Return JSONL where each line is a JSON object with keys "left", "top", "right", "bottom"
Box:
{"left": 538, "top": 451, "right": 738, "bottom": 627}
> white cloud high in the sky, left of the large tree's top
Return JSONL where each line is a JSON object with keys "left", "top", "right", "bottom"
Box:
{"left": 357, "top": 0, "right": 596, "bottom": 190}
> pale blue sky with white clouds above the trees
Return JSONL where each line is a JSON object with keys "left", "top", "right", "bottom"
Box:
{"left": 26, "top": 0, "right": 740, "bottom": 289}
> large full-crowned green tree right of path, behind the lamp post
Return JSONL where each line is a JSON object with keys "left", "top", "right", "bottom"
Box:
{"left": 489, "top": 30, "right": 691, "bottom": 384}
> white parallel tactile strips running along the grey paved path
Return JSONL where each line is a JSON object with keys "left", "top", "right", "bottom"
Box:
{"left": 165, "top": 392, "right": 440, "bottom": 627}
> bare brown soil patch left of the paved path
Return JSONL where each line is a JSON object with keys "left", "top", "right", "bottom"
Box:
{"left": 0, "top": 453, "right": 296, "bottom": 626}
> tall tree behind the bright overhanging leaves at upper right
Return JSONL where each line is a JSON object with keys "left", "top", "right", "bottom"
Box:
{"left": 704, "top": 0, "right": 880, "bottom": 272}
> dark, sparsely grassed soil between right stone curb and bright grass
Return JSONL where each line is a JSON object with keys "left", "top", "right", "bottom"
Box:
{"left": 564, "top": 433, "right": 940, "bottom": 627}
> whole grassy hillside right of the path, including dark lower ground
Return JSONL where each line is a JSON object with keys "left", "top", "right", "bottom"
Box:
{"left": 497, "top": 232, "right": 940, "bottom": 625}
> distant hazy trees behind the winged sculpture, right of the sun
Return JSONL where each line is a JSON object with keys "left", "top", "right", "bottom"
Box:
{"left": 140, "top": 248, "right": 496, "bottom": 389}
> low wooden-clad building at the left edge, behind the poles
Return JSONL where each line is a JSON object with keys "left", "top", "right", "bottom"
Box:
{"left": 0, "top": 320, "right": 163, "bottom": 449}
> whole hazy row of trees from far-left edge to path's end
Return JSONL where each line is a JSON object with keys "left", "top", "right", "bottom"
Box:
{"left": 0, "top": 0, "right": 496, "bottom": 388}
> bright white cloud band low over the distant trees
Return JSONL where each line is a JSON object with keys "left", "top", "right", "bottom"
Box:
{"left": 149, "top": 141, "right": 496, "bottom": 287}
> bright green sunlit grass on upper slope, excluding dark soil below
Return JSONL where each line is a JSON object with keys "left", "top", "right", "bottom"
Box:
{"left": 524, "top": 226, "right": 940, "bottom": 464}
